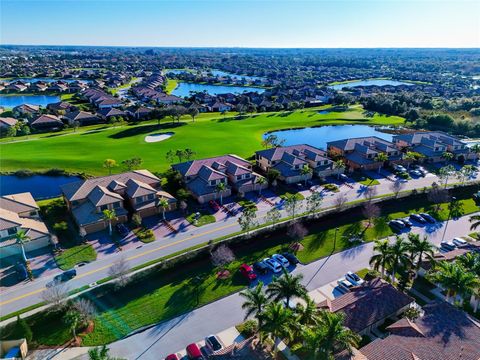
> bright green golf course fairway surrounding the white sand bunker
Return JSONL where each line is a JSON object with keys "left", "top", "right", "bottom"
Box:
{"left": 0, "top": 107, "right": 403, "bottom": 175}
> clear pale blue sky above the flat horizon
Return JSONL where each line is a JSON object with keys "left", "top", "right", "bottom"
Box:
{"left": 0, "top": 0, "right": 480, "bottom": 47}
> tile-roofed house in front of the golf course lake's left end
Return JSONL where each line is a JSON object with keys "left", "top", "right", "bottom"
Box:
{"left": 255, "top": 144, "right": 344, "bottom": 184}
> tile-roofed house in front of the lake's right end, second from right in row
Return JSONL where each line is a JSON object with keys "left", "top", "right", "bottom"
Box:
{"left": 327, "top": 136, "right": 405, "bottom": 171}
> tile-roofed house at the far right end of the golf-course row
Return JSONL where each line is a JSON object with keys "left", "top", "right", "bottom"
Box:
{"left": 393, "top": 131, "right": 476, "bottom": 162}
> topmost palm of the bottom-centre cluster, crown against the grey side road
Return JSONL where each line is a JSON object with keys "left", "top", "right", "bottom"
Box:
{"left": 267, "top": 269, "right": 307, "bottom": 308}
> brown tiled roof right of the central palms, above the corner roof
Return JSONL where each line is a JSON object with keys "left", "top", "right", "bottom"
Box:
{"left": 317, "top": 278, "right": 415, "bottom": 335}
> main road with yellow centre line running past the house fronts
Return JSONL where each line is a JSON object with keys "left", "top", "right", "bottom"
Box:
{"left": 0, "top": 168, "right": 474, "bottom": 316}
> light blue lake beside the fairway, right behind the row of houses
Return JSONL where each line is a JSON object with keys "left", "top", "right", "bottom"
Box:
{"left": 264, "top": 125, "right": 393, "bottom": 149}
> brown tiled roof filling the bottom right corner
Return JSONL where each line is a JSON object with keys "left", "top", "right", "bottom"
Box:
{"left": 360, "top": 302, "right": 480, "bottom": 360}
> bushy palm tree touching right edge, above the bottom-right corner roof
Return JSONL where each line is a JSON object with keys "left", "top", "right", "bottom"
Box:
{"left": 432, "top": 261, "right": 478, "bottom": 302}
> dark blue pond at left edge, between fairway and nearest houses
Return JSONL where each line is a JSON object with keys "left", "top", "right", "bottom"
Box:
{"left": 0, "top": 175, "right": 82, "bottom": 200}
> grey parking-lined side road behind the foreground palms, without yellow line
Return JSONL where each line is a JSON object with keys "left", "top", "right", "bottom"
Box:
{"left": 110, "top": 211, "right": 470, "bottom": 360}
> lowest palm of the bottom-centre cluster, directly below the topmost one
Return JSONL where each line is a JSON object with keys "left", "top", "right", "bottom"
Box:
{"left": 258, "top": 302, "right": 294, "bottom": 359}
